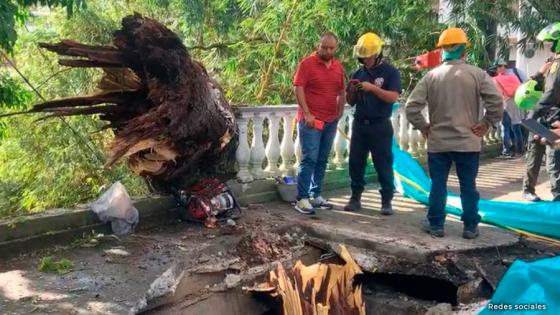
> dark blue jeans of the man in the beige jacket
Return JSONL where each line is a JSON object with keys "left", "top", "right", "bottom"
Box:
{"left": 428, "top": 152, "right": 480, "bottom": 227}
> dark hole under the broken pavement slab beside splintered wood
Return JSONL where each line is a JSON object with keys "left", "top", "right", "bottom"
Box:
{"left": 356, "top": 273, "right": 457, "bottom": 306}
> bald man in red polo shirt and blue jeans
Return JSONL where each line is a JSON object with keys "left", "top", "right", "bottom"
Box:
{"left": 294, "top": 32, "right": 346, "bottom": 214}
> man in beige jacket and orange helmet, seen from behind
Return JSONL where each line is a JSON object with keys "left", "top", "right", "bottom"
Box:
{"left": 406, "top": 28, "right": 503, "bottom": 239}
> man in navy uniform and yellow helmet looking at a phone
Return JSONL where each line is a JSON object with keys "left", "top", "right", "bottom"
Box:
{"left": 344, "top": 33, "right": 401, "bottom": 215}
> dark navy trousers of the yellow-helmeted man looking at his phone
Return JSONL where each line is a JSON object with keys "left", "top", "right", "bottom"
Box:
{"left": 349, "top": 118, "right": 395, "bottom": 205}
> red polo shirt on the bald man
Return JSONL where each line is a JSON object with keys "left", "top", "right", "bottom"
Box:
{"left": 294, "top": 53, "right": 344, "bottom": 122}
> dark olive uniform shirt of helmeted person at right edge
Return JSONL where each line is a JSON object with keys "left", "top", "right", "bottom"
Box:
{"left": 528, "top": 57, "right": 560, "bottom": 120}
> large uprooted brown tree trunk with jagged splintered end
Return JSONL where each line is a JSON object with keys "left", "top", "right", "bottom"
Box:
{"left": 13, "top": 14, "right": 237, "bottom": 191}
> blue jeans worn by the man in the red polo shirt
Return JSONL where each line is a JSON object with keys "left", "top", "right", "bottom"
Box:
{"left": 298, "top": 121, "right": 338, "bottom": 199}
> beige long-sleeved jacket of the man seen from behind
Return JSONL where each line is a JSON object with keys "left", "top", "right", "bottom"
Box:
{"left": 406, "top": 60, "right": 504, "bottom": 152}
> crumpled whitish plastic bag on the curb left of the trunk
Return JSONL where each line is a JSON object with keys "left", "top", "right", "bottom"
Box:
{"left": 91, "top": 182, "right": 139, "bottom": 235}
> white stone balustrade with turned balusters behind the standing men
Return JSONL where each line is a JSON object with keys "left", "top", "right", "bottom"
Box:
{"left": 236, "top": 105, "right": 501, "bottom": 182}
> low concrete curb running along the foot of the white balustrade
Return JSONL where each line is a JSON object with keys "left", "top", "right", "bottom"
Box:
{"left": 0, "top": 144, "right": 500, "bottom": 258}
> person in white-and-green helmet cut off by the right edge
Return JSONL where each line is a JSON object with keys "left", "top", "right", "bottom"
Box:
{"left": 527, "top": 22, "right": 560, "bottom": 201}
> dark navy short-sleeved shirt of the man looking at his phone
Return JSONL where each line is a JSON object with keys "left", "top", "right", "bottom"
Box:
{"left": 350, "top": 62, "right": 402, "bottom": 120}
